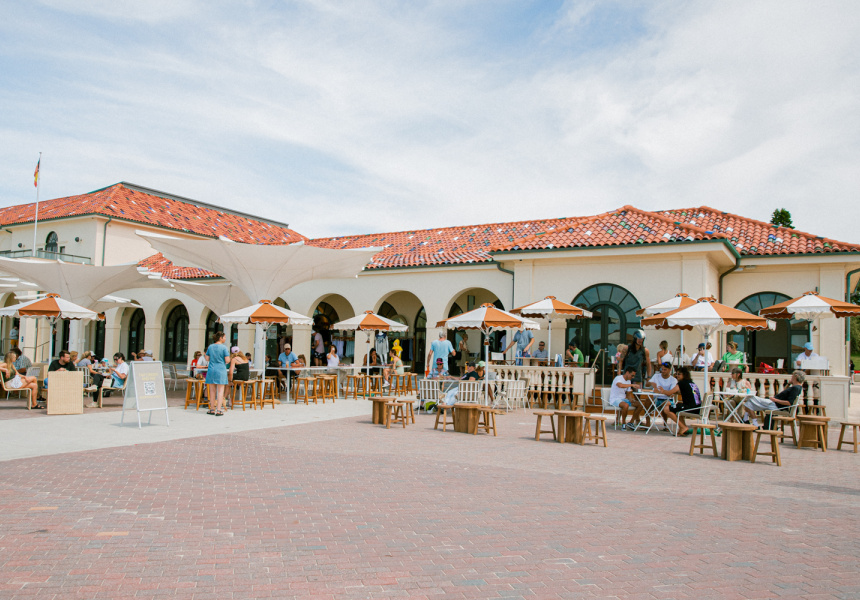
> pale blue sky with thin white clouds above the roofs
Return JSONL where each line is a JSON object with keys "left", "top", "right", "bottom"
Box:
{"left": 0, "top": 0, "right": 860, "bottom": 243}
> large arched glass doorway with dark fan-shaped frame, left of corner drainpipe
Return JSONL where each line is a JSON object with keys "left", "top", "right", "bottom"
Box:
{"left": 565, "top": 283, "right": 641, "bottom": 385}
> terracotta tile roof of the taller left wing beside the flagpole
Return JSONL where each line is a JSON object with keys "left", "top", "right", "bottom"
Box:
{"left": 0, "top": 183, "right": 307, "bottom": 244}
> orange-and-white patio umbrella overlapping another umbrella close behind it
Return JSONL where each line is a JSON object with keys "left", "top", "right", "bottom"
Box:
{"left": 641, "top": 296, "right": 776, "bottom": 394}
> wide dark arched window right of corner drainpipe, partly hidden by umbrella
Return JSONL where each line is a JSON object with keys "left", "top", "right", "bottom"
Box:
{"left": 726, "top": 292, "right": 809, "bottom": 367}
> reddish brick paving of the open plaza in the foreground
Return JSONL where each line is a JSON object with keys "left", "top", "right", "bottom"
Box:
{"left": 0, "top": 394, "right": 860, "bottom": 600}
